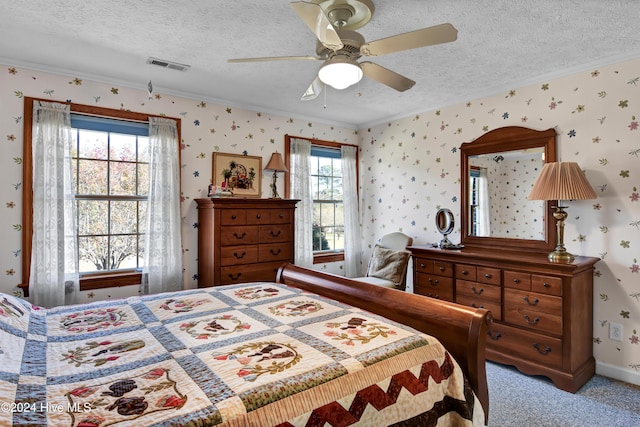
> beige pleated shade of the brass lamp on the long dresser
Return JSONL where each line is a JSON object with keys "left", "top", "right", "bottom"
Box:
{"left": 528, "top": 162, "right": 598, "bottom": 200}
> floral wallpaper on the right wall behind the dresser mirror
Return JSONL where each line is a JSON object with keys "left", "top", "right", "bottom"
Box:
{"left": 359, "top": 59, "right": 640, "bottom": 384}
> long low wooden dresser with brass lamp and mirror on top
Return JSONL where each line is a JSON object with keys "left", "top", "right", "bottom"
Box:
{"left": 409, "top": 246, "right": 599, "bottom": 393}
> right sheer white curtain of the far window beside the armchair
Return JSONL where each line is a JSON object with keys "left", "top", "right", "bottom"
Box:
{"left": 340, "top": 145, "right": 362, "bottom": 277}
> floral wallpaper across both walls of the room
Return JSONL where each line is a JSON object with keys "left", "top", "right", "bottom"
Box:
{"left": 0, "top": 55, "right": 640, "bottom": 384}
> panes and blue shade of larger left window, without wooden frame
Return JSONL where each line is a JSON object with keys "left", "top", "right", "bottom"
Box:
{"left": 71, "top": 114, "right": 149, "bottom": 276}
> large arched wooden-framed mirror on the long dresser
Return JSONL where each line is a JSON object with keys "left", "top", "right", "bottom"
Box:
{"left": 460, "top": 126, "right": 556, "bottom": 252}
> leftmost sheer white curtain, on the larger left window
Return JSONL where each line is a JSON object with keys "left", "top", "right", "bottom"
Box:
{"left": 29, "top": 101, "right": 80, "bottom": 307}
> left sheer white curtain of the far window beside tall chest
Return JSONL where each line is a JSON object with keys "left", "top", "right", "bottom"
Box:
{"left": 289, "top": 138, "right": 313, "bottom": 267}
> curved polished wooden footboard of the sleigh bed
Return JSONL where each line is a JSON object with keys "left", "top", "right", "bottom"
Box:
{"left": 276, "top": 264, "right": 491, "bottom": 420}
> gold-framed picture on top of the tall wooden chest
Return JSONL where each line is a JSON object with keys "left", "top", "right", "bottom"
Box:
{"left": 211, "top": 152, "right": 262, "bottom": 197}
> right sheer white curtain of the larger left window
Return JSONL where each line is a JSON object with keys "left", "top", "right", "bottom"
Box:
{"left": 142, "top": 117, "right": 182, "bottom": 294}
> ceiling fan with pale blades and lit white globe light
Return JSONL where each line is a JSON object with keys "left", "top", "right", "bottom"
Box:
{"left": 228, "top": 0, "right": 458, "bottom": 101}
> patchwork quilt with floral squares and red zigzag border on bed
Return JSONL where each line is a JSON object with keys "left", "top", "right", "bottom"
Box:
{"left": 0, "top": 283, "right": 484, "bottom": 427}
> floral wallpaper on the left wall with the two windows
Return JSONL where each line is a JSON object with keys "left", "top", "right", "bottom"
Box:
{"left": 0, "top": 64, "right": 358, "bottom": 301}
